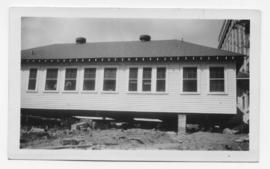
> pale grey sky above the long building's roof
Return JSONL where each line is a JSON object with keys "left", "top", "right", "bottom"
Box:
{"left": 22, "top": 17, "right": 223, "bottom": 49}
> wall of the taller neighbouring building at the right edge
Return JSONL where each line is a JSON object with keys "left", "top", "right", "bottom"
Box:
{"left": 218, "top": 20, "right": 250, "bottom": 123}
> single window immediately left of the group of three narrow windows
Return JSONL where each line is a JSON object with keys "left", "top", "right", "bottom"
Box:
{"left": 103, "top": 68, "right": 116, "bottom": 91}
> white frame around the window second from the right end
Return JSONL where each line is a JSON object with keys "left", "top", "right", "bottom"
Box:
{"left": 180, "top": 64, "right": 201, "bottom": 95}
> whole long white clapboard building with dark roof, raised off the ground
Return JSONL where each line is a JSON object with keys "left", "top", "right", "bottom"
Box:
{"left": 21, "top": 35, "right": 243, "bottom": 132}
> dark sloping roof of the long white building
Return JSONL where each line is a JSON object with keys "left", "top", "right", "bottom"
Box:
{"left": 21, "top": 40, "right": 243, "bottom": 59}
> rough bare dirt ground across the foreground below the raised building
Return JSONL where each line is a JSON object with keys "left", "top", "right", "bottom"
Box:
{"left": 20, "top": 129, "right": 249, "bottom": 151}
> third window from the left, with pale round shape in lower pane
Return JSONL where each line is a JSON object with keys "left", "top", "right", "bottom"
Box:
{"left": 64, "top": 68, "right": 77, "bottom": 90}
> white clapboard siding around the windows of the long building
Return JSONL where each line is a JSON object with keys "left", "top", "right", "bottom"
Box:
{"left": 21, "top": 62, "right": 236, "bottom": 114}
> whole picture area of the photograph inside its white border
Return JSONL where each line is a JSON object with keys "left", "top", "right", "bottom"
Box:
{"left": 9, "top": 7, "right": 257, "bottom": 161}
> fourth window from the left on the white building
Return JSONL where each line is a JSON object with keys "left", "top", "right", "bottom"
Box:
{"left": 83, "top": 68, "right": 96, "bottom": 90}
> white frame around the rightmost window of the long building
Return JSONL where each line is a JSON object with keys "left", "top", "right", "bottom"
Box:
{"left": 207, "top": 64, "right": 228, "bottom": 95}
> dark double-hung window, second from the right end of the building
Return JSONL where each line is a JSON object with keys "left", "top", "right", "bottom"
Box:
{"left": 183, "top": 67, "right": 197, "bottom": 92}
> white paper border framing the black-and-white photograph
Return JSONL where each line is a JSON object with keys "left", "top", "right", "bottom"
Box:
{"left": 8, "top": 7, "right": 261, "bottom": 162}
